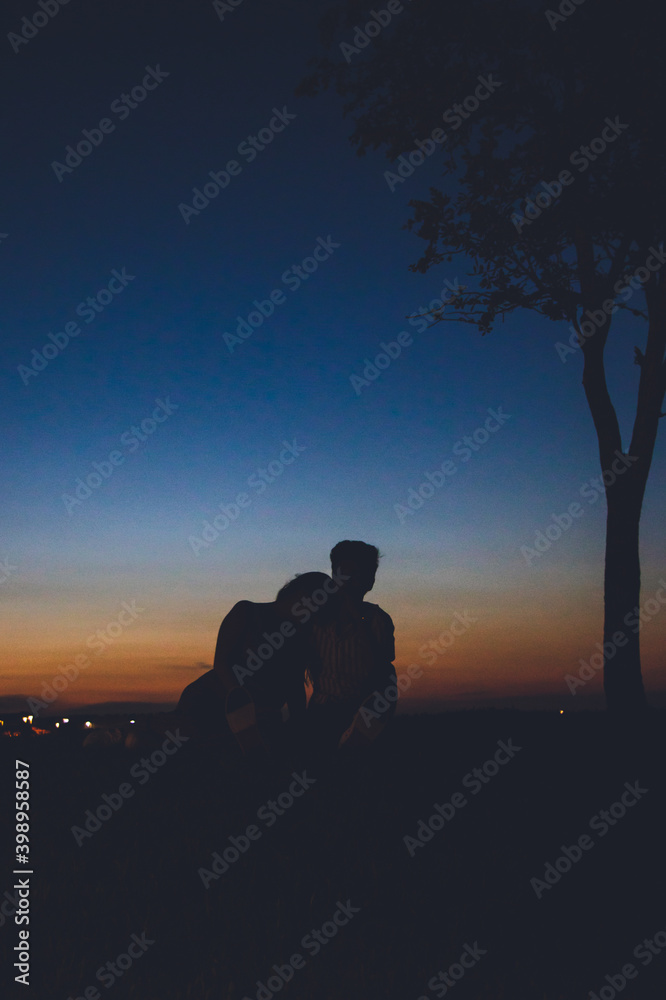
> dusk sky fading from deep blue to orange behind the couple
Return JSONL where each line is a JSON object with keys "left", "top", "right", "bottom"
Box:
{"left": 0, "top": 0, "right": 666, "bottom": 710}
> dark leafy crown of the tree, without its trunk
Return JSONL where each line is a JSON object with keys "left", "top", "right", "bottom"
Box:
{"left": 297, "top": 0, "right": 666, "bottom": 333}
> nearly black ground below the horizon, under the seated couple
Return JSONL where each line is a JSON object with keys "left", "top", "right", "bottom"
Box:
{"left": 0, "top": 711, "right": 666, "bottom": 1000}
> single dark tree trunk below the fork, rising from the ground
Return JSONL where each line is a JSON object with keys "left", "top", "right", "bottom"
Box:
{"left": 603, "top": 480, "right": 646, "bottom": 717}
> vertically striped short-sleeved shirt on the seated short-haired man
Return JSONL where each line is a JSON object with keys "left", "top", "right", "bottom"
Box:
{"left": 310, "top": 601, "right": 395, "bottom": 704}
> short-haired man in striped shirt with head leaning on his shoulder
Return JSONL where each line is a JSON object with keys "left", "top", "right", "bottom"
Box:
{"left": 308, "top": 541, "right": 395, "bottom": 751}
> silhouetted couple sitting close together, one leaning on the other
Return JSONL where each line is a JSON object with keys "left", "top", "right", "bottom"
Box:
{"left": 176, "top": 541, "right": 395, "bottom": 753}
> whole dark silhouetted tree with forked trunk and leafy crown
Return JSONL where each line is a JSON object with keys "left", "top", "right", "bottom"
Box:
{"left": 296, "top": 0, "right": 666, "bottom": 713}
